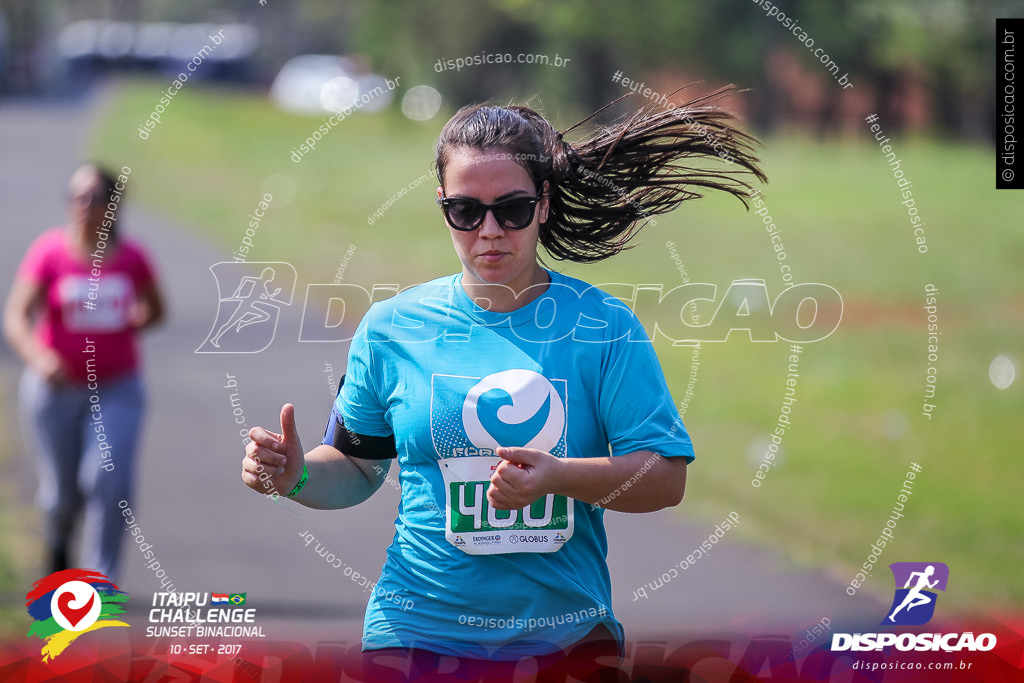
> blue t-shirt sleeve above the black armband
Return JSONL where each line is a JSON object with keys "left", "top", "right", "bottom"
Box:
{"left": 335, "top": 308, "right": 394, "bottom": 436}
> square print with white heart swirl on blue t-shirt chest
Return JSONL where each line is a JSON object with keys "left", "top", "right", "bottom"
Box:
{"left": 430, "top": 368, "right": 566, "bottom": 458}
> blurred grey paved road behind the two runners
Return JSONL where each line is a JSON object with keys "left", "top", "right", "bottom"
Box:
{"left": 0, "top": 88, "right": 885, "bottom": 655}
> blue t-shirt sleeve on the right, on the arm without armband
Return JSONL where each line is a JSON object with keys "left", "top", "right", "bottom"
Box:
{"left": 599, "top": 322, "right": 694, "bottom": 462}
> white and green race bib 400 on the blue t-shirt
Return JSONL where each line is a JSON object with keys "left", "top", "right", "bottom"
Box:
{"left": 438, "top": 457, "right": 573, "bottom": 555}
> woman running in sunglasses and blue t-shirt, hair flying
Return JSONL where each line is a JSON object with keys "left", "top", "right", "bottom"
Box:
{"left": 242, "top": 89, "right": 764, "bottom": 671}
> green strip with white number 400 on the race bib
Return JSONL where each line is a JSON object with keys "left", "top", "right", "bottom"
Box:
{"left": 450, "top": 481, "right": 568, "bottom": 533}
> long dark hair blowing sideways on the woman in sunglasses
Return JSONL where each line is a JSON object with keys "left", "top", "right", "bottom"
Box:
{"left": 435, "top": 85, "right": 767, "bottom": 263}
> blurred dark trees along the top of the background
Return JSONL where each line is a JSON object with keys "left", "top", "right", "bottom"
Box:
{"left": 0, "top": 0, "right": 1022, "bottom": 139}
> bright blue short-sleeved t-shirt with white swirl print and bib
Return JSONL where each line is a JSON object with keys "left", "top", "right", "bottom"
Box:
{"left": 325, "top": 271, "right": 693, "bottom": 659}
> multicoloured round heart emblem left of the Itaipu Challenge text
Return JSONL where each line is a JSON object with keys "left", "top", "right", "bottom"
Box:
{"left": 25, "top": 569, "right": 128, "bottom": 661}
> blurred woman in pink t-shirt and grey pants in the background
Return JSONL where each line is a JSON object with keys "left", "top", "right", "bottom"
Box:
{"left": 4, "top": 165, "right": 164, "bottom": 579}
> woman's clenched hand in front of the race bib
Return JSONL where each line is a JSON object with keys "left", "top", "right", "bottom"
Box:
{"left": 487, "top": 446, "right": 564, "bottom": 510}
